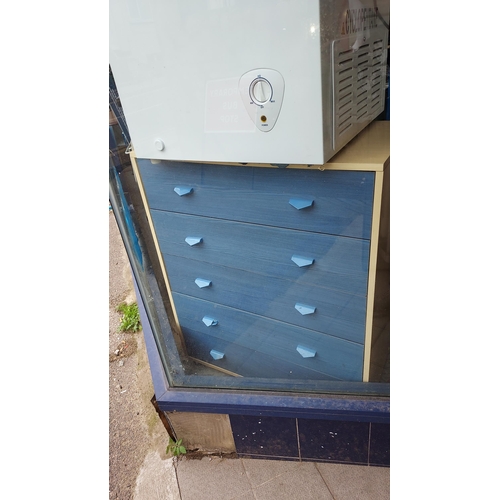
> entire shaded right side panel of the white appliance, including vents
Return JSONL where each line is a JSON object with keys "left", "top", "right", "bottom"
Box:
{"left": 320, "top": 0, "right": 389, "bottom": 159}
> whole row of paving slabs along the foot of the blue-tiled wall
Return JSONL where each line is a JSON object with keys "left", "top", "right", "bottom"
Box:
{"left": 174, "top": 457, "right": 389, "bottom": 500}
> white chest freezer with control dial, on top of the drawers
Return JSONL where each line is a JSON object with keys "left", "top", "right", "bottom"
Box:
{"left": 109, "top": 0, "right": 389, "bottom": 165}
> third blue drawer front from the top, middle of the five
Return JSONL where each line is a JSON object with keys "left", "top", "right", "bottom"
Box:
{"left": 164, "top": 254, "right": 366, "bottom": 343}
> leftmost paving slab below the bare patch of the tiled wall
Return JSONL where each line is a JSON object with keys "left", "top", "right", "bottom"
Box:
{"left": 177, "top": 457, "right": 252, "bottom": 500}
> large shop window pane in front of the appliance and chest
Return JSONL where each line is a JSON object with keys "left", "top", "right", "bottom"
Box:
{"left": 110, "top": 0, "right": 390, "bottom": 395}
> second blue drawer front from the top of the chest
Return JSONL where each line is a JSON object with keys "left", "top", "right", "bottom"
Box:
{"left": 151, "top": 210, "right": 369, "bottom": 296}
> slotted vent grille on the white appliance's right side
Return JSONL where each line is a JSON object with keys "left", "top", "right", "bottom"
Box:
{"left": 333, "top": 29, "right": 387, "bottom": 149}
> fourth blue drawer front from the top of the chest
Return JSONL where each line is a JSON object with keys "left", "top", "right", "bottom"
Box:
{"left": 173, "top": 293, "right": 363, "bottom": 381}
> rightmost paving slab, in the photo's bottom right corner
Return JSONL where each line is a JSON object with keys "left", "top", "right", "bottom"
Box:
{"left": 316, "top": 463, "right": 390, "bottom": 500}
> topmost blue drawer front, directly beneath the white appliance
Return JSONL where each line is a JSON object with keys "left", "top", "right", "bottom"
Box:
{"left": 138, "top": 160, "right": 374, "bottom": 239}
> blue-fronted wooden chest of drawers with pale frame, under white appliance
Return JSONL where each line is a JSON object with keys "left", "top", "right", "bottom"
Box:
{"left": 131, "top": 120, "right": 388, "bottom": 381}
